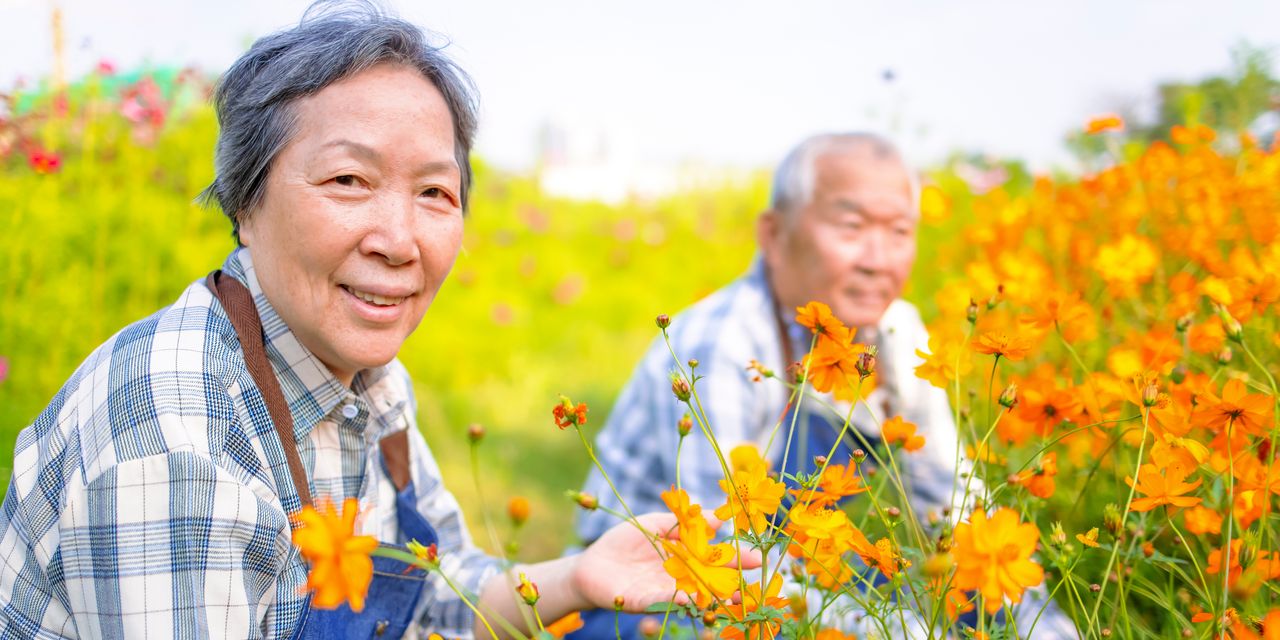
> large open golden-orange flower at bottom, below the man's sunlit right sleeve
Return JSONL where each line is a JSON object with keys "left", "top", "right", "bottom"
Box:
{"left": 951, "top": 508, "right": 1044, "bottom": 613}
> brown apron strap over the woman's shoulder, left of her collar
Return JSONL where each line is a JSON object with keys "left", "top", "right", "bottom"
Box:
{"left": 205, "top": 270, "right": 314, "bottom": 506}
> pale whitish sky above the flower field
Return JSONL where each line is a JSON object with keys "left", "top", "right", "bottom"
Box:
{"left": 0, "top": 0, "right": 1280, "bottom": 175}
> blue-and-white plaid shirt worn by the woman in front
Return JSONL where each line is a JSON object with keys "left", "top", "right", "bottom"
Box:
{"left": 0, "top": 250, "right": 498, "bottom": 639}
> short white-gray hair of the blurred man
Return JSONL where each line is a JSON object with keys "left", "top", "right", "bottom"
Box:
{"left": 769, "top": 132, "right": 920, "bottom": 219}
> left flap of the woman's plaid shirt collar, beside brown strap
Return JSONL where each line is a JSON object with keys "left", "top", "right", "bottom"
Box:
{"left": 223, "top": 247, "right": 350, "bottom": 442}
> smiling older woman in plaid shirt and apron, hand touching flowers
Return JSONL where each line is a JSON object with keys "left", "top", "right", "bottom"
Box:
{"left": 0, "top": 6, "right": 691, "bottom": 639}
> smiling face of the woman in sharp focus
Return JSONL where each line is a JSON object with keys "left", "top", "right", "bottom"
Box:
{"left": 241, "top": 64, "right": 462, "bottom": 385}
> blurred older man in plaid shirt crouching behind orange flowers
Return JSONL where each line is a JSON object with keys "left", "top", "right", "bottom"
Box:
{"left": 579, "top": 133, "right": 1075, "bottom": 637}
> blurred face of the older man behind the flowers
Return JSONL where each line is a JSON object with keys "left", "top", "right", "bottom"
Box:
{"left": 758, "top": 145, "right": 916, "bottom": 328}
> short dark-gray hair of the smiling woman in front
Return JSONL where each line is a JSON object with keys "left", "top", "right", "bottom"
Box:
{"left": 200, "top": 0, "right": 476, "bottom": 242}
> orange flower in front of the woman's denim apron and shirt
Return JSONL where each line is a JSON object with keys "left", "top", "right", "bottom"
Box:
{"left": 293, "top": 498, "right": 378, "bottom": 612}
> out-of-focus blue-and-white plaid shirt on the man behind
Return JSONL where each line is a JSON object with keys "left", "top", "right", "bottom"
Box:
{"left": 577, "top": 257, "right": 959, "bottom": 540}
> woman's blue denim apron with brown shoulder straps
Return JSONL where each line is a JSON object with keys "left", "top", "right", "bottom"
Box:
{"left": 206, "top": 271, "right": 439, "bottom": 640}
